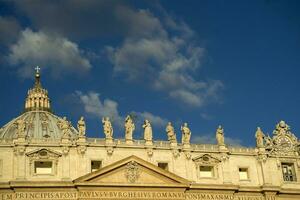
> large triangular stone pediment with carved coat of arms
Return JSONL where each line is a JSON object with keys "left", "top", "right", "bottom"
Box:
{"left": 74, "top": 156, "right": 189, "bottom": 187}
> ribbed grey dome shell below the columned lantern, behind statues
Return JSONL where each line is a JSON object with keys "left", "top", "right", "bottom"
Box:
{"left": 0, "top": 111, "right": 78, "bottom": 140}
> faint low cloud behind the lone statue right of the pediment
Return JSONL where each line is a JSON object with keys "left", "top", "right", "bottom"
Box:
{"left": 192, "top": 134, "right": 242, "bottom": 146}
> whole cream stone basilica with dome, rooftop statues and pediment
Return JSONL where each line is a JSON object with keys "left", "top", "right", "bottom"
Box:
{"left": 0, "top": 70, "right": 300, "bottom": 200}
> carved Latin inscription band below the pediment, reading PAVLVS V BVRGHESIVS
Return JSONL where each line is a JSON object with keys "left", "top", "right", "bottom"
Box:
{"left": 0, "top": 191, "right": 275, "bottom": 200}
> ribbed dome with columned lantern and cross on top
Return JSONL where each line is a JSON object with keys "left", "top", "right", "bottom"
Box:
{"left": 0, "top": 67, "right": 78, "bottom": 140}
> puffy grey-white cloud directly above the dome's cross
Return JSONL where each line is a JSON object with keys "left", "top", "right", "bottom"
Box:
{"left": 8, "top": 29, "right": 92, "bottom": 77}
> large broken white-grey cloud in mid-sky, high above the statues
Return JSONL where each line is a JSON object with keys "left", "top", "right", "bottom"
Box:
{"left": 107, "top": 10, "right": 223, "bottom": 107}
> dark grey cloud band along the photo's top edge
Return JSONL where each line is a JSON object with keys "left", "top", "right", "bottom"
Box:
{"left": 14, "top": 0, "right": 163, "bottom": 40}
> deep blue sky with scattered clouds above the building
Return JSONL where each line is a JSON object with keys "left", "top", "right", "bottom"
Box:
{"left": 0, "top": 0, "right": 300, "bottom": 146}
